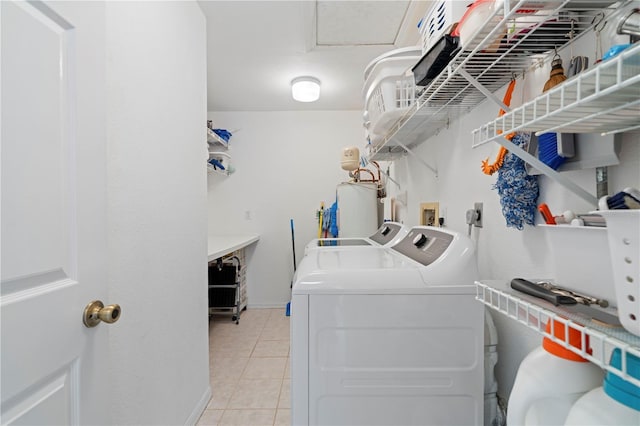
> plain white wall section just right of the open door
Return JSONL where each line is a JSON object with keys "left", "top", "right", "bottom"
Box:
{"left": 106, "top": 2, "right": 210, "bottom": 425}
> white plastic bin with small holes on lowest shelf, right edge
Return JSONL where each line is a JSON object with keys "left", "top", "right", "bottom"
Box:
{"left": 594, "top": 210, "right": 640, "bottom": 336}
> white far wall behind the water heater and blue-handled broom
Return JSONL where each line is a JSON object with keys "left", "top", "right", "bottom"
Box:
{"left": 208, "top": 111, "right": 364, "bottom": 307}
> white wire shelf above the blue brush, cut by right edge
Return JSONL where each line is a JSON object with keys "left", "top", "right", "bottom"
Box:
{"left": 473, "top": 45, "right": 640, "bottom": 148}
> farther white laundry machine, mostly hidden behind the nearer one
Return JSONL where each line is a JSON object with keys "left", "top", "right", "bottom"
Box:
{"left": 304, "top": 222, "right": 409, "bottom": 255}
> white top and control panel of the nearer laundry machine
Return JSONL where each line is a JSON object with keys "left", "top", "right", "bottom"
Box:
{"left": 293, "top": 226, "right": 478, "bottom": 294}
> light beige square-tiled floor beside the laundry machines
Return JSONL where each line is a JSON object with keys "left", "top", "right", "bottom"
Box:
{"left": 198, "top": 307, "right": 291, "bottom": 426}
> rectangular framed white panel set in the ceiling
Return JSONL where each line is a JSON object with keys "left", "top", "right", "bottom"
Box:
{"left": 315, "top": 0, "right": 411, "bottom": 46}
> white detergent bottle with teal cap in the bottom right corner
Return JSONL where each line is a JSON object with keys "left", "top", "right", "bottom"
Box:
{"left": 565, "top": 349, "right": 640, "bottom": 426}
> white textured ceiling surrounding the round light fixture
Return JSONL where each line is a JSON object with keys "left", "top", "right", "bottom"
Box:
{"left": 200, "top": 0, "right": 431, "bottom": 111}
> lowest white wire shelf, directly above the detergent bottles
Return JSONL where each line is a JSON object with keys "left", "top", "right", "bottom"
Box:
{"left": 476, "top": 281, "right": 640, "bottom": 386}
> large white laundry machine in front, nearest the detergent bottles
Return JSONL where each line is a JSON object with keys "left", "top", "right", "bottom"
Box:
{"left": 291, "top": 226, "right": 485, "bottom": 426}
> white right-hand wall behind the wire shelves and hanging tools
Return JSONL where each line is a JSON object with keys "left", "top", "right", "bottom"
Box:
{"left": 390, "top": 89, "right": 640, "bottom": 398}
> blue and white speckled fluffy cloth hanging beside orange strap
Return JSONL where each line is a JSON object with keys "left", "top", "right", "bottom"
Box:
{"left": 493, "top": 132, "right": 539, "bottom": 230}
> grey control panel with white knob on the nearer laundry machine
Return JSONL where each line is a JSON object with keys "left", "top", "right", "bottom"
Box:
{"left": 391, "top": 226, "right": 454, "bottom": 266}
